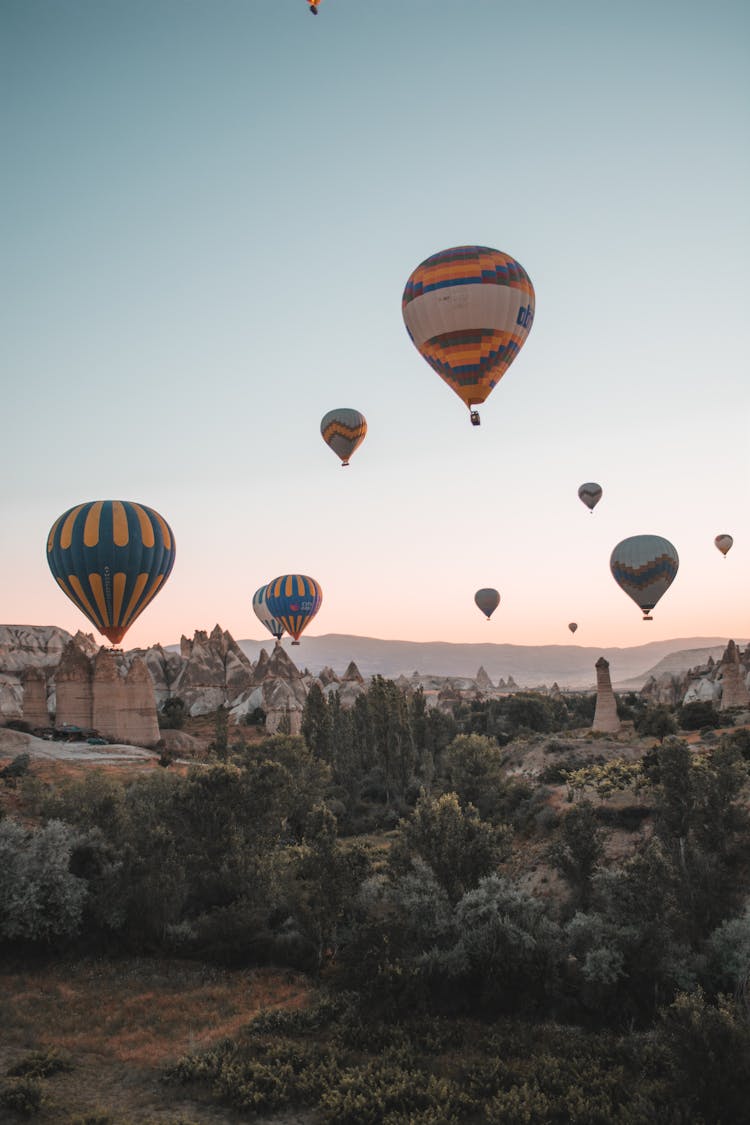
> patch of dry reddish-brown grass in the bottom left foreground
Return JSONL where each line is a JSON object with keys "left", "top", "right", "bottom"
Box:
{"left": 0, "top": 959, "right": 309, "bottom": 1125}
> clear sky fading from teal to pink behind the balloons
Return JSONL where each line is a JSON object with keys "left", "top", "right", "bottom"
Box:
{"left": 0, "top": 0, "right": 750, "bottom": 659}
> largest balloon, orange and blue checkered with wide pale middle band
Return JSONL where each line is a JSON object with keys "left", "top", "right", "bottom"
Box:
{"left": 401, "top": 246, "right": 534, "bottom": 425}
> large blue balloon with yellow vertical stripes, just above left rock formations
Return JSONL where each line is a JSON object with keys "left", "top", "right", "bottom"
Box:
{"left": 47, "top": 500, "right": 174, "bottom": 645}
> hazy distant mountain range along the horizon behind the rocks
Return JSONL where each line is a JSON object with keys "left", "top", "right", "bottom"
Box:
{"left": 237, "top": 633, "right": 744, "bottom": 690}
